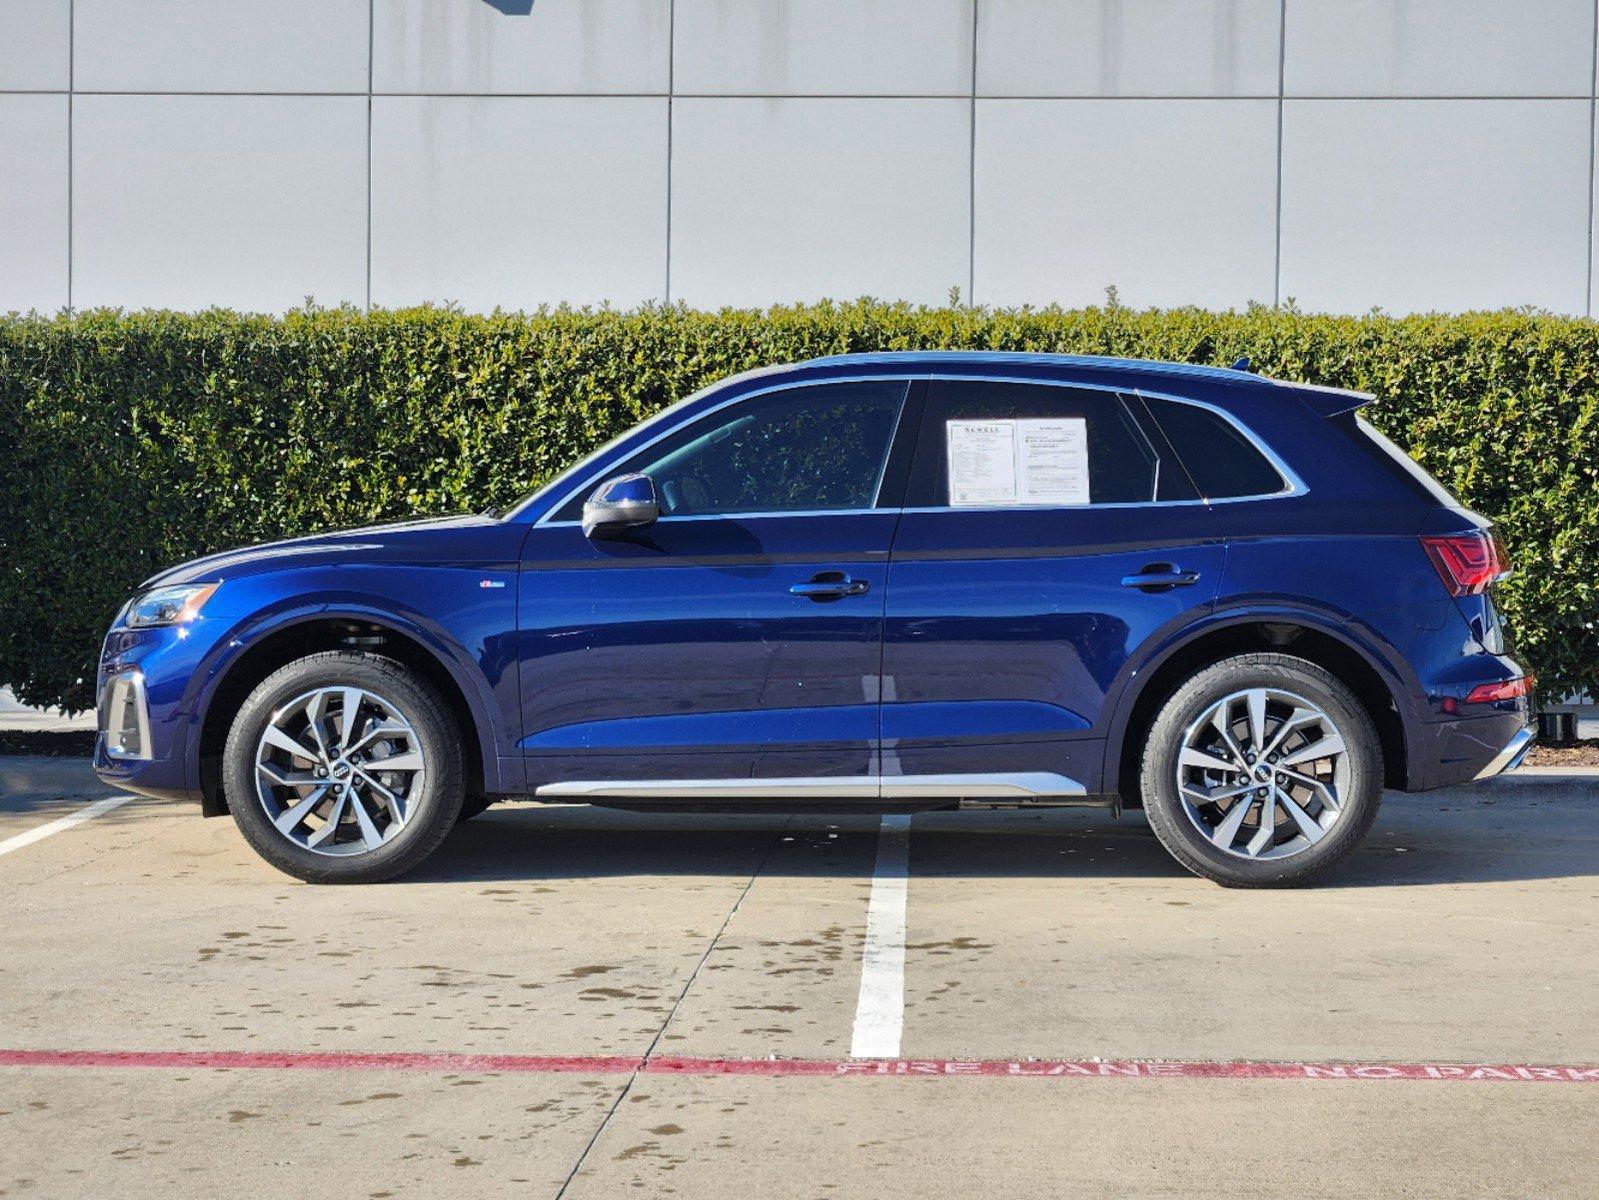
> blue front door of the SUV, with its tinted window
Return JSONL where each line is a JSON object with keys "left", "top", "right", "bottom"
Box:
{"left": 518, "top": 379, "right": 908, "bottom": 798}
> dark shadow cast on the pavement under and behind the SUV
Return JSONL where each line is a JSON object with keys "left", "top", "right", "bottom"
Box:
{"left": 401, "top": 776, "right": 1599, "bottom": 888}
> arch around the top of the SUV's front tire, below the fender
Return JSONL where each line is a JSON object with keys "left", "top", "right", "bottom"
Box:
{"left": 192, "top": 611, "right": 500, "bottom": 816}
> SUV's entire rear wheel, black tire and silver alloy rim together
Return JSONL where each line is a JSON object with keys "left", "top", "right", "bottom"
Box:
{"left": 1140, "top": 653, "right": 1383, "bottom": 888}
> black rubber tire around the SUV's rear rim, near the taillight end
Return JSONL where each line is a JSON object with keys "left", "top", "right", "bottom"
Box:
{"left": 1138, "top": 653, "right": 1383, "bottom": 888}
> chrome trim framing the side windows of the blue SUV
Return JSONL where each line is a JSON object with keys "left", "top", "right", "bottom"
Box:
{"left": 521, "top": 371, "right": 1310, "bottom": 528}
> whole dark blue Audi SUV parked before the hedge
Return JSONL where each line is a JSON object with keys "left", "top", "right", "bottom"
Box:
{"left": 96, "top": 352, "right": 1532, "bottom": 886}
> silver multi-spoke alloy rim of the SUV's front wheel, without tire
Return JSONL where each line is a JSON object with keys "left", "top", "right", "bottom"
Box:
{"left": 254, "top": 686, "right": 427, "bottom": 856}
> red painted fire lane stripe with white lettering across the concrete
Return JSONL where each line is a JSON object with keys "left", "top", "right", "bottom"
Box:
{"left": 0, "top": 1050, "right": 1599, "bottom": 1083}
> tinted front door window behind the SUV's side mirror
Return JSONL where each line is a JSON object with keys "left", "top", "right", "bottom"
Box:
{"left": 560, "top": 381, "right": 905, "bottom": 520}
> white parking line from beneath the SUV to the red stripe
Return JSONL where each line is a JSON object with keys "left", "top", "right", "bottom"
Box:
{"left": 849, "top": 813, "right": 910, "bottom": 1058}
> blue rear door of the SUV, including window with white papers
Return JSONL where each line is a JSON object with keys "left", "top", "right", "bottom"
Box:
{"left": 883, "top": 379, "right": 1223, "bottom": 795}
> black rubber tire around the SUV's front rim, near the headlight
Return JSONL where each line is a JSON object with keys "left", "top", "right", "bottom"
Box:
{"left": 222, "top": 651, "right": 465, "bottom": 883}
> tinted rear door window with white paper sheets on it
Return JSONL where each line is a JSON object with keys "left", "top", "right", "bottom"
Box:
{"left": 905, "top": 381, "right": 1161, "bottom": 507}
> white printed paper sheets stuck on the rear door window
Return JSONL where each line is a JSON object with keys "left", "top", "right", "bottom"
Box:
{"left": 943, "top": 416, "right": 1089, "bottom": 509}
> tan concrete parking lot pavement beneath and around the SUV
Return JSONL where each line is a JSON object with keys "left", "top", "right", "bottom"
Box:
{"left": 0, "top": 758, "right": 1599, "bottom": 1198}
